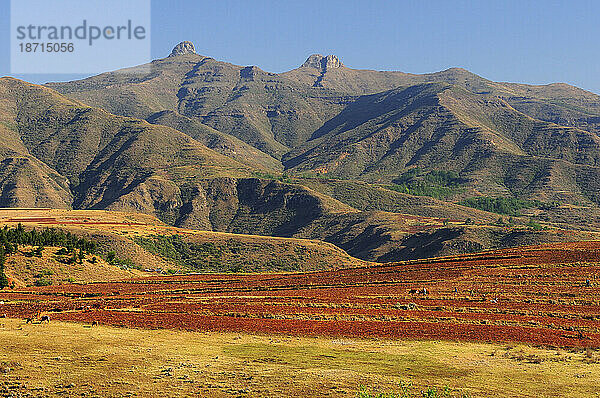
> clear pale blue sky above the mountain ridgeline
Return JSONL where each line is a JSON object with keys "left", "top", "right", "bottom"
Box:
{"left": 0, "top": 0, "right": 600, "bottom": 94}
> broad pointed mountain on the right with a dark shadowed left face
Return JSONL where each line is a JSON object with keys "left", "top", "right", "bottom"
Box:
{"left": 284, "top": 83, "right": 600, "bottom": 203}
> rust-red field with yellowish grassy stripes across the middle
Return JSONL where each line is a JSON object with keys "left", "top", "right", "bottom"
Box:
{"left": 0, "top": 242, "right": 600, "bottom": 347}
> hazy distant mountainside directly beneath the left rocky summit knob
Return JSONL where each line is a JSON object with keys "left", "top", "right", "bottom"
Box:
{"left": 49, "top": 54, "right": 347, "bottom": 158}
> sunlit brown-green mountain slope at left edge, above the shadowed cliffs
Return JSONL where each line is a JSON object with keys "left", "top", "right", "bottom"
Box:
{"left": 0, "top": 78, "right": 251, "bottom": 211}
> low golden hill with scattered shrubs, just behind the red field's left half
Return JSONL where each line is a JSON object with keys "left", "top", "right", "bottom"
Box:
{"left": 0, "top": 209, "right": 369, "bottom": 280}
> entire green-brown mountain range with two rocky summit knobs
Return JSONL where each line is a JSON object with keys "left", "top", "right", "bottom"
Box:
{"left": 0, "top": 43, "right": 600, "bottom": 261}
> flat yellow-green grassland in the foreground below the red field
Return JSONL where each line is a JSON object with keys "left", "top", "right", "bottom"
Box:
{"left": 0, "top": 319, "right": 600, "bottom": 397}
